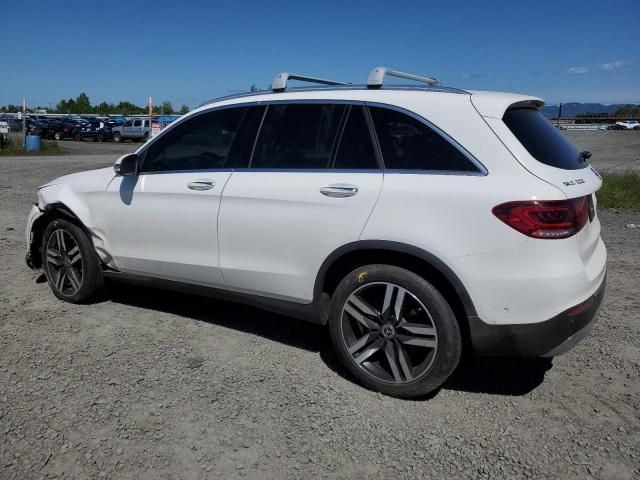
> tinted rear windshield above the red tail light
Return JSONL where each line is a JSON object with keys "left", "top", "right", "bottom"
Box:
{"left": 502, "top": 108, "right": 587, "bottom": 170}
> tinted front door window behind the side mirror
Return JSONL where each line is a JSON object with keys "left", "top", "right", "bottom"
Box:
{"left": 143, "top": 108, "right": 247, "bottom": 172}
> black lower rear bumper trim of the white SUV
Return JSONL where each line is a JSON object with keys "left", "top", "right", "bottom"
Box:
{"left": 469, "top": 277, "right": 606, "bottom": 357}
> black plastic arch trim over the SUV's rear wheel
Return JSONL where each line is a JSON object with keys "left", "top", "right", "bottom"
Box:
{"left": 314, "top": 240, "right": 477, "bottom": 339}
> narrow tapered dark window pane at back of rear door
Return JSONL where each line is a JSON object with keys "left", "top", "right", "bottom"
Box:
{"left": 333, "top": 105, "right": 380, "bottom": 170}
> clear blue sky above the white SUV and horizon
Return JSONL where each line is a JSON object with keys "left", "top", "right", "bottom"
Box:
{"left": 0, "top": 0, "right": 640, "bottom": 107}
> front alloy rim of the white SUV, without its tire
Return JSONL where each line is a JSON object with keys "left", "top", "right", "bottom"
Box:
{"left": 46, "top": 228, "right": 84, "bottom": 296}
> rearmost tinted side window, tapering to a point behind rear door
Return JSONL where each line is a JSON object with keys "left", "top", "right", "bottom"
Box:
{"left": 370, "top": 107, "right": 478, "bottom": 172}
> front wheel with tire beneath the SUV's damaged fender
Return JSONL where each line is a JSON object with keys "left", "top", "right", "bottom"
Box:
{"left": 42, "top": 219, "right": 103, "bottom": 303}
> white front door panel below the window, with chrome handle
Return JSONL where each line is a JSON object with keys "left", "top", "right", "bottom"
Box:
{"left": 106, "top": 171, "right": 231, "bottom": 286}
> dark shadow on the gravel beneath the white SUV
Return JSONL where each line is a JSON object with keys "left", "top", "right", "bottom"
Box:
{"left": 104, "top": 281, "right": 552, "bottom": 400}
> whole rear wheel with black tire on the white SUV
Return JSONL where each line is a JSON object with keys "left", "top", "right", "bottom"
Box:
{"left": 329, "top": 265, "right": 462, "bottom": 398}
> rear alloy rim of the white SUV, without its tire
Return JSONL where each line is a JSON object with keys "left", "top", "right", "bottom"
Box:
{"left": 340, "top": 282, "right": 438, "bottom": 384}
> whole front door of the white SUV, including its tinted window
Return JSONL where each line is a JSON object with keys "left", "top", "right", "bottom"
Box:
{"left": 107, "top": 107, "right": 247, "bottom": 286}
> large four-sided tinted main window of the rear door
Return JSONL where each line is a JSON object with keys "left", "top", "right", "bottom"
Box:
{"left": 251, "top": 104, "right": 346, "bottom": 170}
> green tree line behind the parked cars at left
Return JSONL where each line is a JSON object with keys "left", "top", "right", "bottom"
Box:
{"left": 0, "top": 92, "right": 189, "bottom": 115}
